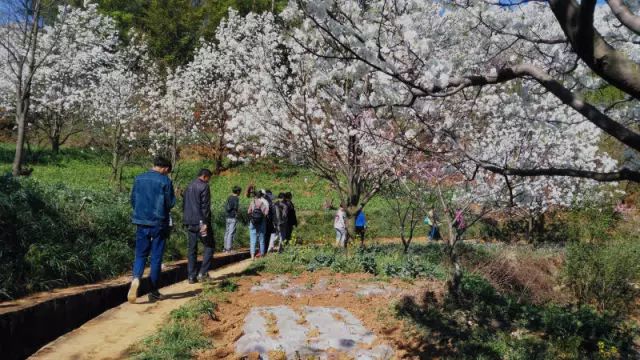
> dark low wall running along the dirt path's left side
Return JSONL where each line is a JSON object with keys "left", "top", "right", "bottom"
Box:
{"left": 0, "top": 252, "right": 249, "bottom": 360}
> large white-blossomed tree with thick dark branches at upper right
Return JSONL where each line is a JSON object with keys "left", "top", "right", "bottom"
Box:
{"left": 286, "top": 0, "right": 640, "bottom": 186}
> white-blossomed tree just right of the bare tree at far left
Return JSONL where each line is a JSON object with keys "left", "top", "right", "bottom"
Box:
{"left": 32, "top": 4, "right": 118, "bottom": 153}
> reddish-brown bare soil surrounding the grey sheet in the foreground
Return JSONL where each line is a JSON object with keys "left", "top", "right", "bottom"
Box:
{"left": 198, "top": 271, "right": 444, "bottom": 359}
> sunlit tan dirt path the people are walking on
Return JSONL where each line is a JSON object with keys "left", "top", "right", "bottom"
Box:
{"left": 30, "top": 260, "right": 251, "bottom": 360}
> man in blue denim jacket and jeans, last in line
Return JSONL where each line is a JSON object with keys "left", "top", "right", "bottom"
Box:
{"left": 127, "top": 157, "right": 176, "bottom": 303}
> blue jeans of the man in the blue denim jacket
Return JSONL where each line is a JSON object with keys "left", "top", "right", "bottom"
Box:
{"left": 133, "top": 225, "right": 169, "bottom": 290}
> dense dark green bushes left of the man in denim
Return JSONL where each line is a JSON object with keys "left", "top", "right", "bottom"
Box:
{"left": 0, "top": 176, "right": 134, "bottom": 298}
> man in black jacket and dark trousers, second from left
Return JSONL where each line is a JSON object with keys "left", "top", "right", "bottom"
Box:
{"left": 183, "top": 169, "right": 214, "bottom": 284}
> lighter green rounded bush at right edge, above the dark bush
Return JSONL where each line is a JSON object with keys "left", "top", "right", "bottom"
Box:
{"left": 564, "top": 240, "right": 640, "bottom": 312}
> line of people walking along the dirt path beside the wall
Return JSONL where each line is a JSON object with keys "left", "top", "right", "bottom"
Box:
{"left": 127, "top": 157, "right": 298, "bottom": 303}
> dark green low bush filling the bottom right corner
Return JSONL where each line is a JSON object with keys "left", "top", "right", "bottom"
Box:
{"left": 395, "top": 274, "right": 637, "bottom": 359}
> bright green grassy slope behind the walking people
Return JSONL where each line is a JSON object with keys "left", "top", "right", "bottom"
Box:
{"left": 0, "top": 144, "right": 426, "bottom": 248}
